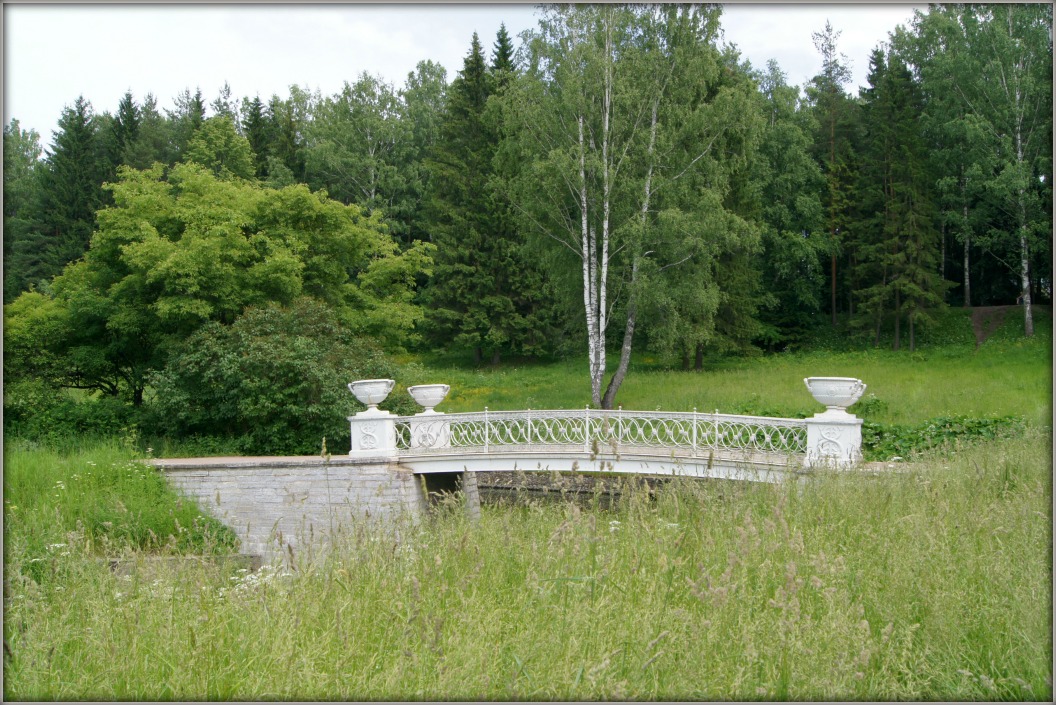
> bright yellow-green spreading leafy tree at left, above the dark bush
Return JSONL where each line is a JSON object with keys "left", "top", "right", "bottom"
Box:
{"left": 4, "top": 164, "right": 432, "bottom": 403}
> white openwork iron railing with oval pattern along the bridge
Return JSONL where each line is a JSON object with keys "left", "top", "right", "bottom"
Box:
{"left": 396, "top": 408, "right": 807, "bottom": 455}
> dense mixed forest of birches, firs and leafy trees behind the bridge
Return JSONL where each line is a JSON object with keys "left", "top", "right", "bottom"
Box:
{"left": 3, "top": 4, "right": 1053, "bottom": 450}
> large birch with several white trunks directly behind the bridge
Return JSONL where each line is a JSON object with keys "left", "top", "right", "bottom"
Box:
{"left": 509, "top": 5, "right": 755, "bottom": 408}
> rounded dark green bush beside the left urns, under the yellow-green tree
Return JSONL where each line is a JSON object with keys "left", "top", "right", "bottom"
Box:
{"left": 151, "top": 299, "right": 416, "bottom": 454}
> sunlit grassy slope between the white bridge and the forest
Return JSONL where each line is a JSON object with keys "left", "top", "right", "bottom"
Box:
{"left": 408, "top": 310, "right": 1052, "bottom": 424}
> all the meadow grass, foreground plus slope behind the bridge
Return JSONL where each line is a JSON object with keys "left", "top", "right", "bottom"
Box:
{"left": 4, "top": 308, "right": 1053, "bottom": 701}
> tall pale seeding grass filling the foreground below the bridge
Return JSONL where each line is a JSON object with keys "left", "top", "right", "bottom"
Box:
{"left": 4, "top": 431, "right": 1053, "bottom": 701}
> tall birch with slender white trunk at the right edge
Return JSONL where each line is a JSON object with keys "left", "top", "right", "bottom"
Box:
{"left": 914, "top": 4, "right": 1053, "bottom": 336}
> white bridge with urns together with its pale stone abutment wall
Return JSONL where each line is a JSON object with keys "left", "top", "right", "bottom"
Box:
{"left": 151, "top": 377, "right": 865, "bottom": 557}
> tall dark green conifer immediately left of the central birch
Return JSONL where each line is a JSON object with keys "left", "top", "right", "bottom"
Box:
{"left": 426, "top": 33, "right": 545, "bottom": 363}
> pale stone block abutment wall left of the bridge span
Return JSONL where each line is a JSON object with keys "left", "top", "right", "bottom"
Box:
{"left": 153, "top": 456, "right": 427, "bottom": 560}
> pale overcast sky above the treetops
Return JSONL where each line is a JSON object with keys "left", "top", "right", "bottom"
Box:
{"left": 3, "top": 2, "right": 923, "bottom": 147}
